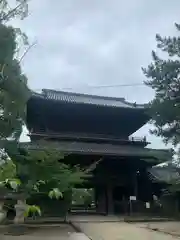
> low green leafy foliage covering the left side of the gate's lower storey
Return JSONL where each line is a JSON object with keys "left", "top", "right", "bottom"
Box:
{"left": 5, "top": 149, "right": 88, "bottom": 198}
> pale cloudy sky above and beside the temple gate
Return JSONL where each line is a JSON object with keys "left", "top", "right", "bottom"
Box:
{"left": 14, "top": 0, "right": 180, "bottom": 148}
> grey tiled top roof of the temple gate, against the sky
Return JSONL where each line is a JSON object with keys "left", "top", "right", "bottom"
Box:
{"left": 33, "top": 89, "right": 145, "bottom": 109}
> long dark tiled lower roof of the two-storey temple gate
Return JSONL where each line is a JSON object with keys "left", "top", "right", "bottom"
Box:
{"left": 20, "top": 141, "right": 167, "bottom": 160}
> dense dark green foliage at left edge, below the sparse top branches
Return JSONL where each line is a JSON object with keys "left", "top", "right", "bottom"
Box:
{"left": 0, "top": 25, "right": 29, "bottom": 139}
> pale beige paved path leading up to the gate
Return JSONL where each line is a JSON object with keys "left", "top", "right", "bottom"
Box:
{"left": 74, "top": 222, "right": 180, "bottom": 240}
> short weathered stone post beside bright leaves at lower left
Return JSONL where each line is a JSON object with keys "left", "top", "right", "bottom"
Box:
{"left": 14, "top": 199, "right": 27, "bottom": 224}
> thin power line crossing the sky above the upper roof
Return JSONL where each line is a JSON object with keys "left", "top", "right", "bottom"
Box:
{"left": 34, "top": 83, "right": 146, "bottom": 91}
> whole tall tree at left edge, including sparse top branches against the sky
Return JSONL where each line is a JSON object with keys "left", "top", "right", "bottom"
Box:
{"left": 0, "top": 0, "right": 30, "bottom": 140}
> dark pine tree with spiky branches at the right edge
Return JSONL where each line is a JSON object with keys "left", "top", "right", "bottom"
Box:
{"left": 143, "top": 24, "right": 180, "bottom": 145}
